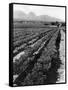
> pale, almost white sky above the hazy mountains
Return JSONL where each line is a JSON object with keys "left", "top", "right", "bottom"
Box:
{"left": 13, "top": 4, "right": 65, "bottom": 21}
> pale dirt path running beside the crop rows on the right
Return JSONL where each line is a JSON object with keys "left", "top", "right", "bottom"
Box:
{"left": 57, "top": 30, "right": 65, "bottom": 83}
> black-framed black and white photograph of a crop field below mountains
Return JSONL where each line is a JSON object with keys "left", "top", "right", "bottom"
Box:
{"left": 9, "top": 3, "right": 66, "bottom": 87}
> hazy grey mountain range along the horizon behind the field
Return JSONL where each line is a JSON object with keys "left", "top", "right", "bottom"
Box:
{"left": 14, "top": 11, "right": 61, "bottom": 22}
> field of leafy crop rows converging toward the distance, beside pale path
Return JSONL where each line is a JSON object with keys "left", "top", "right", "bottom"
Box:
{"left": 13, "top": 24, "right": 61, "bottom": 86}
